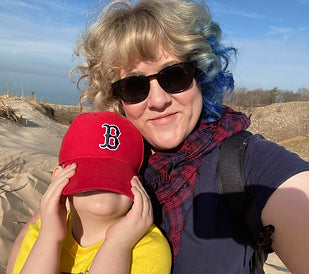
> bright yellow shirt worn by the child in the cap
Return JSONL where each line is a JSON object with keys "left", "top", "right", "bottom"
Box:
{"left": 13, "top": 214, "right": 171, "bottom": 274}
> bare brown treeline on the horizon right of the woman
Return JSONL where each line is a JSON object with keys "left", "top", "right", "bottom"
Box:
{"left": 224, "top": 87, "right": 309, "bottom": 108}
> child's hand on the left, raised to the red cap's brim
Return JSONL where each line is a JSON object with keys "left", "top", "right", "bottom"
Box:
{"left": 39, "top": 164, "right": 76, "bottom": 242}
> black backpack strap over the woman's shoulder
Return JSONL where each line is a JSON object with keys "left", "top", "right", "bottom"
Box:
{"left": 216, "top": 131, "right": 274, "bottom": 273}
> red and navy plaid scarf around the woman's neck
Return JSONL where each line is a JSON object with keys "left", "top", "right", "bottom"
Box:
{"left": 144, "top": 107, "right": 250, "bottom": 261}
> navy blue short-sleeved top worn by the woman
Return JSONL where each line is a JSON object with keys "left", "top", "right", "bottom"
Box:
{"left": 173, "top": 135, "right": 309, "bottom": 274}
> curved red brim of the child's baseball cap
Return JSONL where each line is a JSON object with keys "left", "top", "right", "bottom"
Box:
{"left": 62, "top": 158, "right": 137, "bottom": 200}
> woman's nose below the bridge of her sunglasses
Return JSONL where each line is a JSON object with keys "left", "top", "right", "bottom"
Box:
{"left": 147, "top": 79, "right": 172, "bottom": 110}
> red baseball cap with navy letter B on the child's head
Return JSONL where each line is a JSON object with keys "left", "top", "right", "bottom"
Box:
{"left": 59, "top": 111, "right": 144, "bottom": 199}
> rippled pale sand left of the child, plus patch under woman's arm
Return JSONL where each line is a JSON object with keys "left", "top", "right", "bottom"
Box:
{"left": 0, "top": 100, "right": 289, "bottom": 274}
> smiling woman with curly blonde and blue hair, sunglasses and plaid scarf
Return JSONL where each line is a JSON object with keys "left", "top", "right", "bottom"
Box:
{"left": 6, "top": 0, "right": 309, "bottom": 273}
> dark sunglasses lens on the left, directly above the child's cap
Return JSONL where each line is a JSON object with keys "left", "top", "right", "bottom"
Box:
{"left": 112, "top": 76, "right": 149, "bottom": 104}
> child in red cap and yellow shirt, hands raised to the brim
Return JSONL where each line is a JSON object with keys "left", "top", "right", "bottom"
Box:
{"left": 13, "top": 111, "right": 171, "bottom": 274}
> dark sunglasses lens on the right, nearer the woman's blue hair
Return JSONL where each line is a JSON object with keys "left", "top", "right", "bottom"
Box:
{"left": 157, "top": 63, "right": 195, "bottom": 93}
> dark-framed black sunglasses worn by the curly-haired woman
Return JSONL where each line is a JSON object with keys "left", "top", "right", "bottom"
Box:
{"left": 112, "top": 62, "right": 196, "bottom": 104}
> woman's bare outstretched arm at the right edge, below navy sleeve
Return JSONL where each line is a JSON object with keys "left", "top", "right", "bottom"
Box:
{"left": 262, "top": 171, "right": 309, "bottom": 273}
